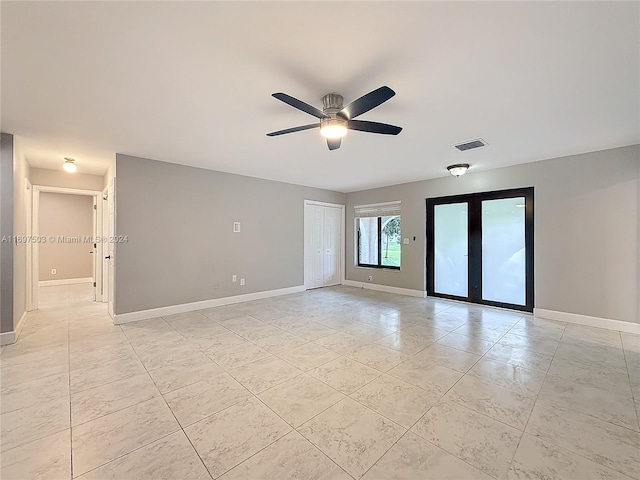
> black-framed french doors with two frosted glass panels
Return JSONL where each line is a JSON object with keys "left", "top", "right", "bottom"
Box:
{"left": 427, "top": 187, "right": 534, "bottom": 312}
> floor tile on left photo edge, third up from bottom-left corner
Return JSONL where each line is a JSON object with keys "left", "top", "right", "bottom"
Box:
{"left": 0, "top": 373, "right": 69, "bottom": 413}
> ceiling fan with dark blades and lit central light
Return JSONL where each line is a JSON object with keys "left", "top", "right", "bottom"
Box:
{"left": 267, "top": 86, "right": 402, "bottom": 150}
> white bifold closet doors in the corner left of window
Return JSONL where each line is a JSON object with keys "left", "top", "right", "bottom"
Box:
{"left": 304, "top": 200, "right": 344, "bottom": 289}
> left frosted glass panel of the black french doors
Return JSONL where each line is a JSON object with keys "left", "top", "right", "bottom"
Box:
{"left": 434, "top": 202, "right": 469, "bottom": 297}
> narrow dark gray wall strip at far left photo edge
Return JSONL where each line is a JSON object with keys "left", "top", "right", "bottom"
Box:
{"left": 0, "top": 133, "right": 13, "bottom": 333}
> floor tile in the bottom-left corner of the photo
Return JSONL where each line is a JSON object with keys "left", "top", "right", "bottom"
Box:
{"left": 0, "top": 429, "right": 71, "bottom": 480}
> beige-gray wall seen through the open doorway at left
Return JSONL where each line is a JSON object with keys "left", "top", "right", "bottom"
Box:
{"left": 38, "top": 192, "right": 94, "bottom": 280}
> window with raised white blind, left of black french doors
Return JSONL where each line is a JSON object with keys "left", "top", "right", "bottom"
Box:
{"left": 355, "top": 202, "right": 402, "bottom": 270}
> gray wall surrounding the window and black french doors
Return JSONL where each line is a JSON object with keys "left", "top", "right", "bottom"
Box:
{"left": 346, "top": 145, "right": 640, "bottom": 323}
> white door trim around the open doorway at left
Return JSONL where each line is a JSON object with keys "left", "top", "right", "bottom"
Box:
{"left": 27, "top": 185, "right": 103, "bottom": 310}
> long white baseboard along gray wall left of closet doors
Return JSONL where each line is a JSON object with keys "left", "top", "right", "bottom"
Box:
{"left": 113, "top": 285, "right": 305, "bottom": 325}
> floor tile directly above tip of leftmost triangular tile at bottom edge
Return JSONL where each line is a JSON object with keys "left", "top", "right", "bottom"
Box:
{"left": 164, "top": 372, "right": 251, "bottom": 427}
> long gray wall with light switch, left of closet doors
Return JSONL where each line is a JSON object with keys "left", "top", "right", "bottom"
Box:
{"left": 115, "top": 154, "right": 346, "bottom": 314}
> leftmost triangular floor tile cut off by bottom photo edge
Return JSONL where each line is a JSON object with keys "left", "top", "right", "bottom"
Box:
{"left": 79, "top": 431, "right": 211, "bottom": 480}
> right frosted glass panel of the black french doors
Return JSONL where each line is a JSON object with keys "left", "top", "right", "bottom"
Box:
{"left": 482, "top": 197, "right": 527, "bottom": 305}
